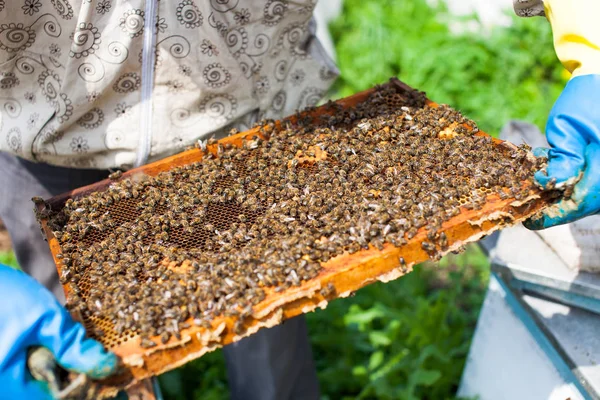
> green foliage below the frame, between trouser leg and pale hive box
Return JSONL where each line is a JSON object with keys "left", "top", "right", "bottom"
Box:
{"left": 307, "top": 247, "right": 489, "bottom": 400}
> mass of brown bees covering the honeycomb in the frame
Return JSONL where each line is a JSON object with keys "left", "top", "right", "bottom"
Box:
{"left": 42, "top": 87, "right": 542, "bottom": 347}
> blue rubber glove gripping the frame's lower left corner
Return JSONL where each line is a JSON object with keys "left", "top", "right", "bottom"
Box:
{"left": 0, "top": 265, "right": 118, "bottom": 400}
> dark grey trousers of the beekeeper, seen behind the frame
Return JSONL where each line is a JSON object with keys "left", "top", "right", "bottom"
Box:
{"left": 0, "top": 152, "right": 319, "bottom": 400}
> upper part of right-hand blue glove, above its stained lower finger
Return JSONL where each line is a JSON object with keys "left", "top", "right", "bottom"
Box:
{"left": 535, "top": 75, "right": 600, "bottom": 187}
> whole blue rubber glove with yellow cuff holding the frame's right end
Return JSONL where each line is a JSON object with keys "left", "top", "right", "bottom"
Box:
{"left": 525, "top": 75, "right": 600, "bottom": 230}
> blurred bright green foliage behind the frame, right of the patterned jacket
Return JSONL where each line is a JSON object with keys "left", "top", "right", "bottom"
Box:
{"left": 331, "top": 0, "right": 565, "bottom": 135}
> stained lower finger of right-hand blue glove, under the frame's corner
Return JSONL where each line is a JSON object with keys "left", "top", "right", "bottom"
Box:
{"left": 524, "top": 143, "right": 600, "bottom": 230}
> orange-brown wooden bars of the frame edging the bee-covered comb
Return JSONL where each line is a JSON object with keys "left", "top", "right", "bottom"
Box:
{"left": 38, "top": 78, "right": 550, "bottom": 395}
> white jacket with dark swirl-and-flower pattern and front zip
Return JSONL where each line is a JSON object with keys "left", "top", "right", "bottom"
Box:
{"left": 0, "top": 0, "right": 337, "bottom": 168}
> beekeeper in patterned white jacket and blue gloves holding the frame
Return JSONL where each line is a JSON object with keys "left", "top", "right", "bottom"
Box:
{"left": 0, "top": 0, "right": 600, "bottom": 400}
